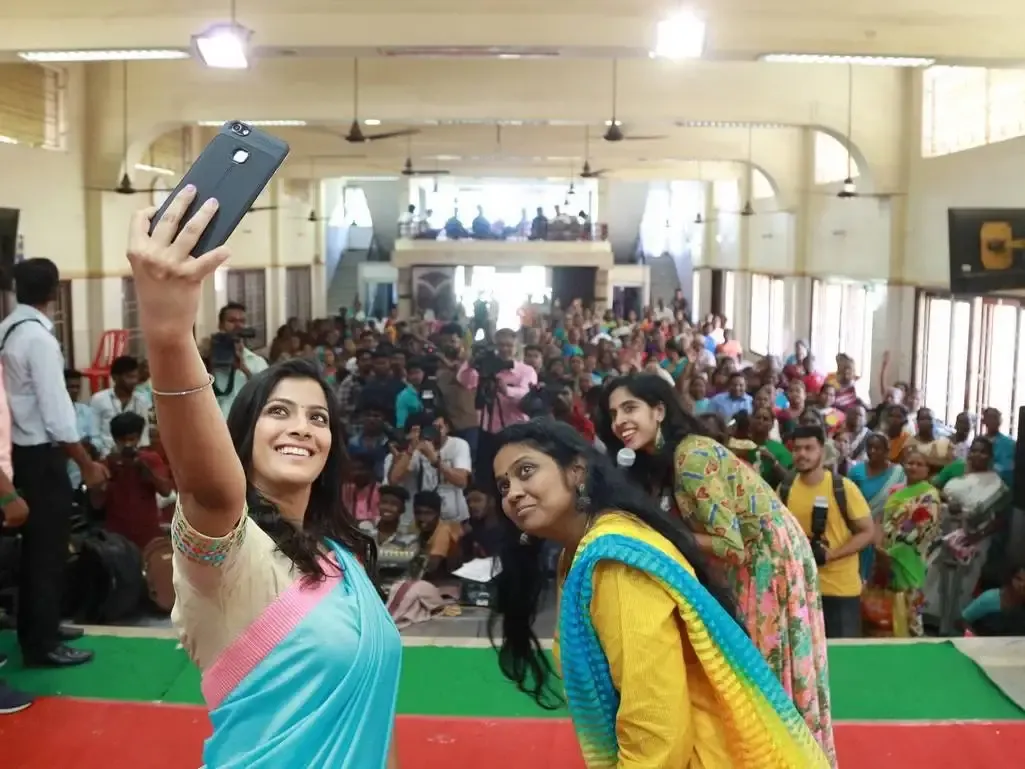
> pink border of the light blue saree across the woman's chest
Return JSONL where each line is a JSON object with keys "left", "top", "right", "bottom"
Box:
{"left": 201, "top": 558, "right": 342, "bottom": 710}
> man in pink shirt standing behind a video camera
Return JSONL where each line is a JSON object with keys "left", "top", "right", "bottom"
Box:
{"left": 456, "top": 328, "right": 537, "bottom": 478}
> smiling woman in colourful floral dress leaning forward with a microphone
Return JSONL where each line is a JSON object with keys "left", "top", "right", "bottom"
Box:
{"left": 599, "top": 374, "right": 836, "bottom": 767}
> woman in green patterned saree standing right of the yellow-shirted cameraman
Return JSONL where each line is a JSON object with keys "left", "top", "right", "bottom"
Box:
{"left": 870, "top": 449, "right": 941, "bottom": 638}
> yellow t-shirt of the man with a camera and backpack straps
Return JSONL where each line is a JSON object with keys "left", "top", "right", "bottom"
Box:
{"left": 783, "top": 471, "right": 872, "bottom": 598}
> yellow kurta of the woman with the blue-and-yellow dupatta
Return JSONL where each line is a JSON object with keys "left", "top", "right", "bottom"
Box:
{"left": 555, "top": 515, "right": 735, "bottom": 769}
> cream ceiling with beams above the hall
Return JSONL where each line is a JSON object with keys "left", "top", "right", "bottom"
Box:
{"left": 0, "top": 0, "right": 1025, "bottom": 179}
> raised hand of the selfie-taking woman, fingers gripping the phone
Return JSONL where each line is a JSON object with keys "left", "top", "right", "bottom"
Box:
{"left": 128, "top": 185, "right": 231, "bottom": 349}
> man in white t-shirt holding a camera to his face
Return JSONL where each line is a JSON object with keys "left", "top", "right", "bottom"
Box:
{"left": 384, "top": 414, "right": 473, "bottom": 523}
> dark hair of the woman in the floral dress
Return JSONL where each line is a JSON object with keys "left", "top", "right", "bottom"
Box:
{"left": 597, "top": 373, "right": 708, "bottom": 490}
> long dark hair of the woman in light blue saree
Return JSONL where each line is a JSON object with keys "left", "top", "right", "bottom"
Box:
{"left": 228, "top": 358, "right": 377, "bottom": 580}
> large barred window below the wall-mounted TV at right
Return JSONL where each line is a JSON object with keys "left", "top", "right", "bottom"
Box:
{"left": 915, "top": 291, "right": 1025, "bottom": 435}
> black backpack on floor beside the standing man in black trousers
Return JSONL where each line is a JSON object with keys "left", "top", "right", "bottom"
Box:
{"left": 69, "top": 529, "right": 147, "bottom": 624}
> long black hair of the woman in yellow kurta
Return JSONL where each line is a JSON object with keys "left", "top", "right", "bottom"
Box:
{"left": 488, "top": 419, "right": 737, "bottom": 710}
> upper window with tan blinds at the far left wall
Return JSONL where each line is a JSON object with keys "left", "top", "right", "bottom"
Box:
{"left": 0, "top": 64, "right": 65, "bottom": 150}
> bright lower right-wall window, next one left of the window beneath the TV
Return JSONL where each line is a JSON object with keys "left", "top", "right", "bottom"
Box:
{"left": 810, "top": 280, "right": 873, "bottom": 391}
